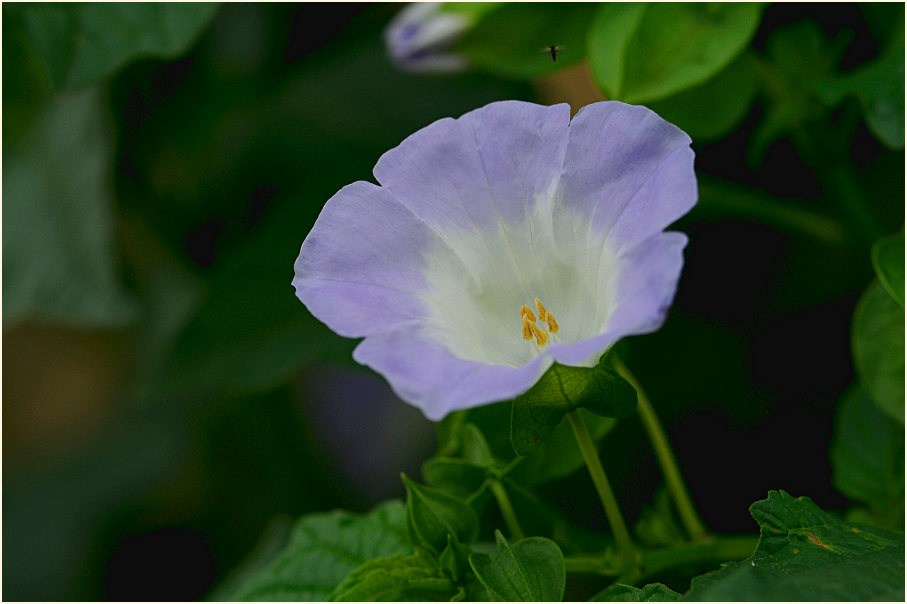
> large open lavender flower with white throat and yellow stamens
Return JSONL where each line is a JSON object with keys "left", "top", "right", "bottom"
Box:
{"left": 293, "top": 101, "right": 697, "bottom": 420}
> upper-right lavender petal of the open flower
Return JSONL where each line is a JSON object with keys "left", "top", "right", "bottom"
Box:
{"left": 558, "top": 101, "right": 697, "bottom": 253}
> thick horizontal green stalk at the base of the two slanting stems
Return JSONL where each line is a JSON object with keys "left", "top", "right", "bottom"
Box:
{"left": 564, "top": 535, "right": 759, "bottom": 585}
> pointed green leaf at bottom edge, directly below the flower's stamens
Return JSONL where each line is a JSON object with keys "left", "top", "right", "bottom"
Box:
{"left": 469, "top": 531, "right": 566, "bottom": 602}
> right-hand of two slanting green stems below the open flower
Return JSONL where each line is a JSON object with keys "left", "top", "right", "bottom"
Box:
{"left": 615, "top": 359, "right": 706, "bottom": 539}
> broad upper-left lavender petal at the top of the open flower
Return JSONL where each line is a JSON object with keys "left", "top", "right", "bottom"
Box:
{"left": 374, "top": 101, "right": 570, "bottom": 234}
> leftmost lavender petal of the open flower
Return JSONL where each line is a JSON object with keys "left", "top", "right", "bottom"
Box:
{"left": 293, "top": 181, "right": 438, "bottom": 337}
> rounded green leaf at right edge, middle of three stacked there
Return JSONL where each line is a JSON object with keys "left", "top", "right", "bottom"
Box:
{"left": 852, "top": 280, "right": 904, "bottom": 424}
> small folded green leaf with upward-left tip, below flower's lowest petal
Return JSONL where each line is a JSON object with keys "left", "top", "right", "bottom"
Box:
{"left": 401, "top": 474, "right": 479, "bottom": 554}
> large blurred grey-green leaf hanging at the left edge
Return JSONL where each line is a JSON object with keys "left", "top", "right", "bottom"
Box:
{"left": 3, "top": 87, "right": 135, "bottom": 327}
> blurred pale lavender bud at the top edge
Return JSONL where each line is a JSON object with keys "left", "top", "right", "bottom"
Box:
{"left": 384, "top": 2, "right": 471, "bottom": 72}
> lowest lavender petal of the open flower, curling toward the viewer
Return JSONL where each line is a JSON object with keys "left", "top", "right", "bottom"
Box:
{"left": 353, "top": 321, "right": 552, "bottom": 421}
